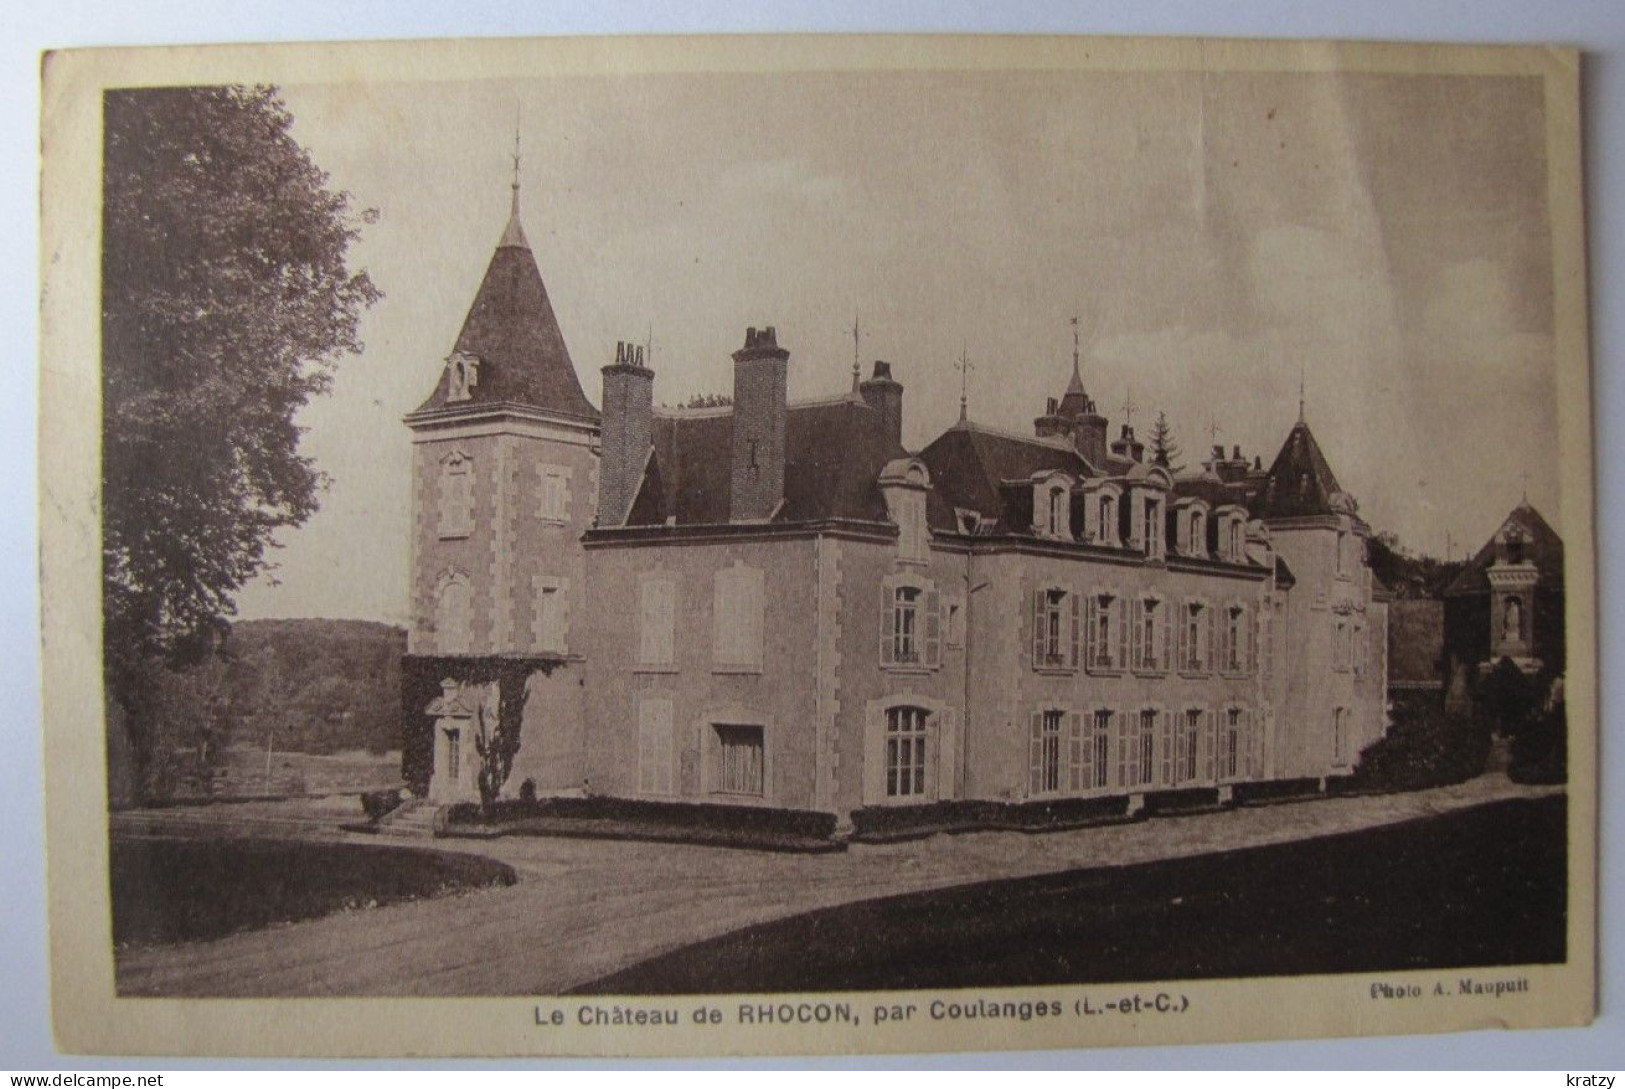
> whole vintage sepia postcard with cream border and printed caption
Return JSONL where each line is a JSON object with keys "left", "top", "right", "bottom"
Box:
{"left": 31, "top": 37, "right": 1596, "bottom": 1055}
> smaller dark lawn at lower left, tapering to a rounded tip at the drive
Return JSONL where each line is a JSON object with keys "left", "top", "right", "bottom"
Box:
{"left": 111, "top": 835, "right": 515, "bottom": 946}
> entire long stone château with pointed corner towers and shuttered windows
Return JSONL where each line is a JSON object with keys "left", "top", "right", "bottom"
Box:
{"left": 405, "top": 189, "right": 1391, "bottom": 829}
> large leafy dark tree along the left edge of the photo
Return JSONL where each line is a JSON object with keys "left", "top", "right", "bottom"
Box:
{"left": 102, "top": 86, "right": 379, "bottom": 796}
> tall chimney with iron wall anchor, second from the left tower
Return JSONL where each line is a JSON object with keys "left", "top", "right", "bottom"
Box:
{"left": 728, "top": 325, "right": 790, "bottom": 522}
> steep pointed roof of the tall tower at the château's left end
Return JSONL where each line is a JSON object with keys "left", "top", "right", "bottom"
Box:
{"left": 413, "top": 202, "right": 598, "bottom": 421}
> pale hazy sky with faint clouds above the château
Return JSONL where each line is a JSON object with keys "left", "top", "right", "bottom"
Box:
{"left": 241, "top": 73, "right": 1560, "bottom": 623}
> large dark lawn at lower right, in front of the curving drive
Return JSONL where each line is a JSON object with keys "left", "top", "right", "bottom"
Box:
{"left": 577, "top": 796, "right": 1567, "bottom": 995}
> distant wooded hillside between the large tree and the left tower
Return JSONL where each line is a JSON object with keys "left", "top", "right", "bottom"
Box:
{"left": 218, "top": 619, "right": 406, "bottom": 753}
